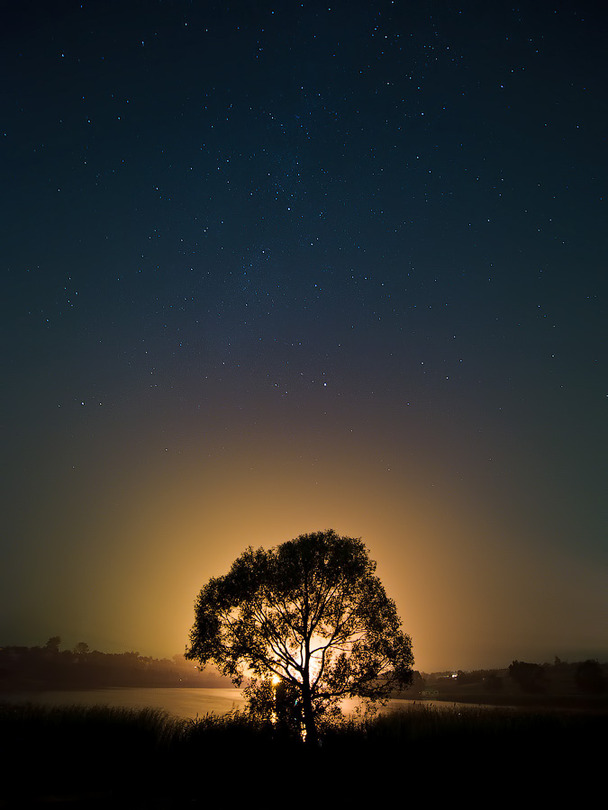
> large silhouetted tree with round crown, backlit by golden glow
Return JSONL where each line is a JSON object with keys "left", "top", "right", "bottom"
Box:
{"left": 186, "top": 530, "right": 413, "bottom": 743}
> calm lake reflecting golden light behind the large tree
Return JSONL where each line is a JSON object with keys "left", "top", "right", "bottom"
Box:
{"left": 0, "top": 687, "right": 482, "bottom": 720}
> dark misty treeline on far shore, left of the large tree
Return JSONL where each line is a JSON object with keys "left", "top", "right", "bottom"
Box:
{"left": 0, "top": 636, "right": 231, "bottom": 692}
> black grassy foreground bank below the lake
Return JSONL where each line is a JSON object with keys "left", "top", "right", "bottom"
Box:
{"left": 0, "top": 704, "right": 608, "bottom": 808}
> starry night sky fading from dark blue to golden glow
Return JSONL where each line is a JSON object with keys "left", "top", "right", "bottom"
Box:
{"left": 0, "top": 0, "right": 608, "bottom": 671}
